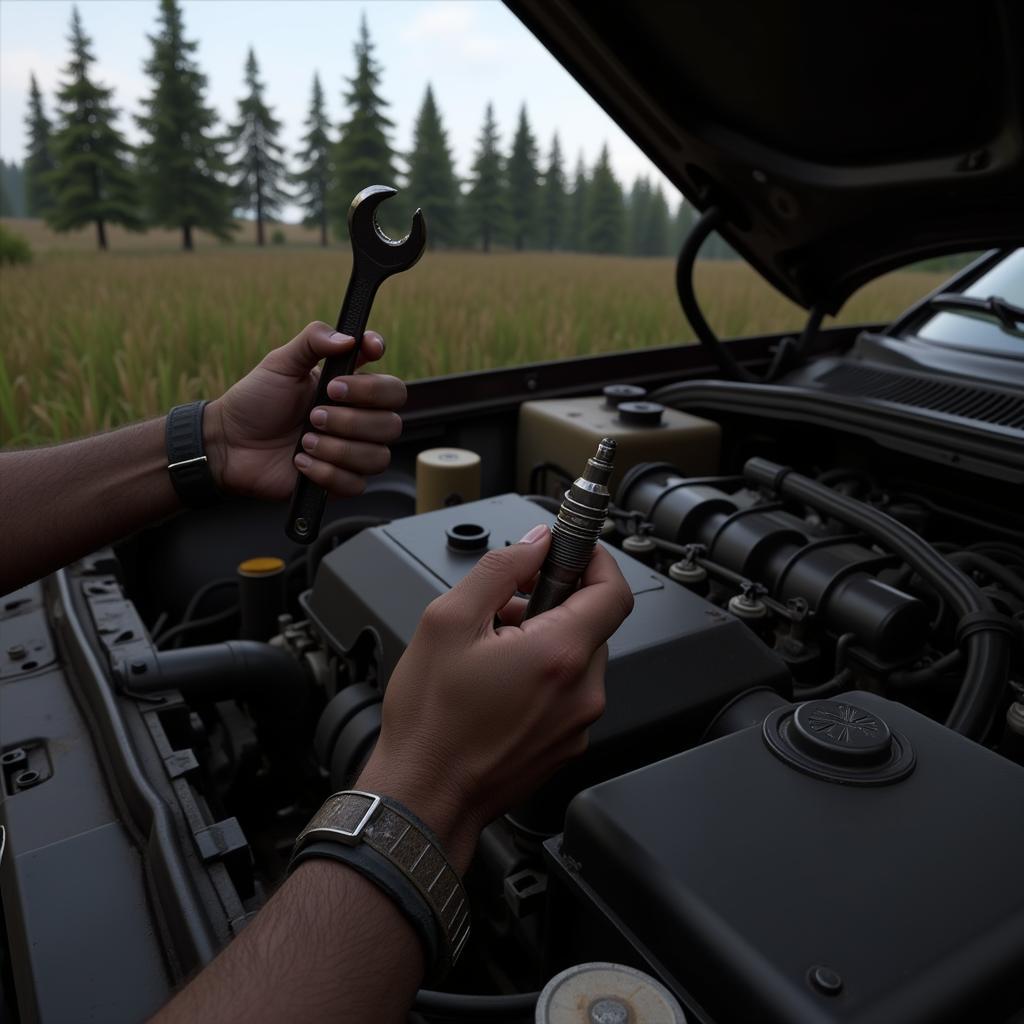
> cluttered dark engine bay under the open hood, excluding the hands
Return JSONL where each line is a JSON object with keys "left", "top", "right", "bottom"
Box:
{"left": 0, "top": 362, "right": 1024, "bottom": 1022}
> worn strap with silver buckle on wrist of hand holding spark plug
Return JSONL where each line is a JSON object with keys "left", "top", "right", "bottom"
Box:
{"left": 289, "top": 790, "right": 470, "bottom": 978}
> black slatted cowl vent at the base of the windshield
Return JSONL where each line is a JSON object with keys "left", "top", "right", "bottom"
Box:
{"left": 817, "top": 364, "right": 1024, "bottom": 430}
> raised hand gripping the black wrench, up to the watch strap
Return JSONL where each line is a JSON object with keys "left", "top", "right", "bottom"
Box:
{"left": 203, "top": 322, "right": 406, "bottom": 499}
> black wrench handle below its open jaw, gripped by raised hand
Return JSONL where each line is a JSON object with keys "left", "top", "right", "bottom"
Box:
{"left": 285, "top": 265, "right": 383, "bottom": 544}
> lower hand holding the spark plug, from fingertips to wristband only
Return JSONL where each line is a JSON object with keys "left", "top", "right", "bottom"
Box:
{"left": 358, "top": 526, "right": 633, "bottom": 869}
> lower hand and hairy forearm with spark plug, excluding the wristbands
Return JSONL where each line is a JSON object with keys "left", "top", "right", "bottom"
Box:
{"left": 150, "top": 526, "right": 633, "bottom": 1024}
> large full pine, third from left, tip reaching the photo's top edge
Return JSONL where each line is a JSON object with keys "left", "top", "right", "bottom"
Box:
{"left": 136, "top": 0, "right": 234, "bottom": 249}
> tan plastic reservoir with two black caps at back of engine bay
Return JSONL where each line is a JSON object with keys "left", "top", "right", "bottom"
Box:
{"left": 516, "top": 384, "right": 722, "bottom": 495}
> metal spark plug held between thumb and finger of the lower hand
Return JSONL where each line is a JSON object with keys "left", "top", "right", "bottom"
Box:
{"left": 523, "top": 437, "right": 615, "bottom": 620}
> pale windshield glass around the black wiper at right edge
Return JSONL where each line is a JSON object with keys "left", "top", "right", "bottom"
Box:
{"left": 915, "top": 249, "right": 1024, "bottom": 358}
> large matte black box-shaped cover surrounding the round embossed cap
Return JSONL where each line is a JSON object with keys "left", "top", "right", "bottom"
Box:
{"left": 549, "top": 692, "right": 1024, "bottom": 1024}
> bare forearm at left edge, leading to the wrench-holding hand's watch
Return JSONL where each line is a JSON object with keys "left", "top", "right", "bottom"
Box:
{"left": 0, "top": 418, "right": 181, "bottom": 594}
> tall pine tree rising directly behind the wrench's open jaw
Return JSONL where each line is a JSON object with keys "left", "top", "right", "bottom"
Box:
{"left": 331, "top": 15, "right": 399, "bottom": 238}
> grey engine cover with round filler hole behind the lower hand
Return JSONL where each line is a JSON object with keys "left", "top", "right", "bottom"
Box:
{"left": 304, "top": 495, "right": 791, "bottom": 830}
